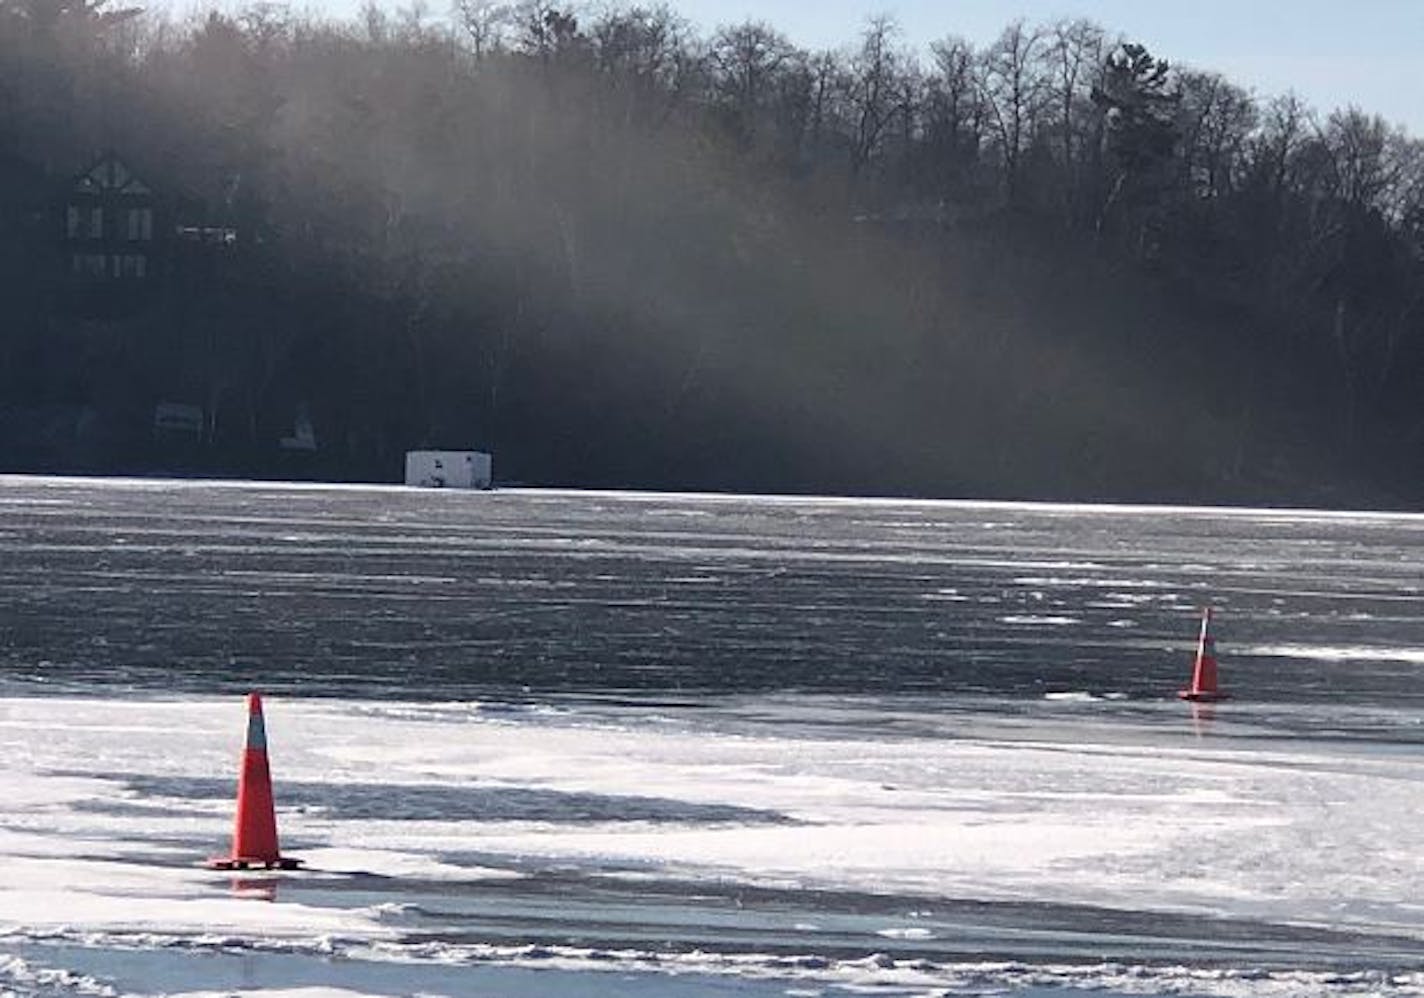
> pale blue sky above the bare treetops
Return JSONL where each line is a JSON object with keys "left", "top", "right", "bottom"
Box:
{"left": 668, "top": 0, "right": 1424, "bottom": 137}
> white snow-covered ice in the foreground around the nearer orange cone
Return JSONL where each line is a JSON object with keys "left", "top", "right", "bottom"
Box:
{"left": 0, "top": 698, "right": 1424, "bottom": 994}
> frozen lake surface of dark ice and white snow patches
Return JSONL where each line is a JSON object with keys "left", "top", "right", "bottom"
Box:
{"left": 0, "top": 477, "right": 1424, "bottom": 998}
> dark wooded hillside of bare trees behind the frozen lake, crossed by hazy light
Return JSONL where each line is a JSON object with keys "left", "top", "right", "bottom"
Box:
{"left": 0, "top": 0, "right": 1424, "bottom": 503}
